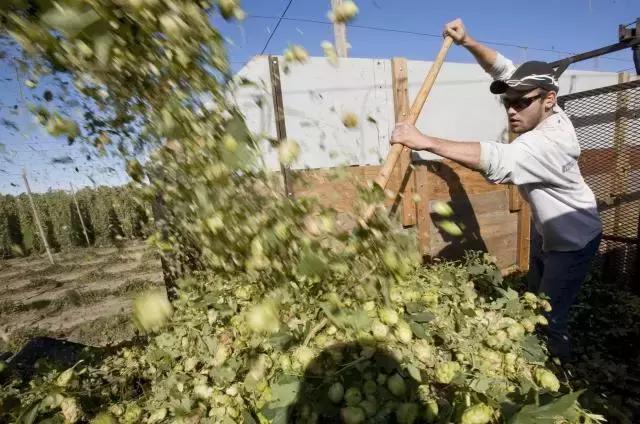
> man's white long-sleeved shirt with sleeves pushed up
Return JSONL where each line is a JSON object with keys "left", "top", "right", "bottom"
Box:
{"left": 480, "top": 54, "right": 602, "bottom": 251}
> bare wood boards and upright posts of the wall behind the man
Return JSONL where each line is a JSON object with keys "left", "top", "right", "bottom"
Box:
{"left": 271, "top": 58, "right": 530, "bottom": 271}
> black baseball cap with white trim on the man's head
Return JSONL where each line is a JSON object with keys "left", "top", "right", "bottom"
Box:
{"left": 489, "top": 61, "right": 559, "bottom": 94}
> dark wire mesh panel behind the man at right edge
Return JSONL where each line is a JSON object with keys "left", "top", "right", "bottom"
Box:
{"left": 558, "top": 80, "right": 640, "bottom": 291}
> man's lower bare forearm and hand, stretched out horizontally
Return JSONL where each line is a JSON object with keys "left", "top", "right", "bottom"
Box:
{"left": 391, "top": 123, "right": 480, "bottom": 170}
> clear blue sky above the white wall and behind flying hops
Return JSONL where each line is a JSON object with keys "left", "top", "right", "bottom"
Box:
{"left": 0, "top": 0, "right": 640, "bottom": 193}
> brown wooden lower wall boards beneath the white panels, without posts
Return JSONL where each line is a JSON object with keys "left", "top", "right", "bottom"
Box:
{"left": 294, "top": 161, "right": 529, "bottom": 269}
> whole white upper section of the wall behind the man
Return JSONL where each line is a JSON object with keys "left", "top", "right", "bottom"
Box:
{"left": 236, "top": 57, "right": 617, "bottom": 169}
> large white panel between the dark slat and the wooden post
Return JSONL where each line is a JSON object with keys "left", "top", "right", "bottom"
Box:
{"left": 282, "top": 58, "right": 393, "bottom": 168}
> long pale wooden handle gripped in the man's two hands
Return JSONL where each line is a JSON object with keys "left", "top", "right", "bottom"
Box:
{"left": 374, "top": 37, "right": 453, "bottom": 190}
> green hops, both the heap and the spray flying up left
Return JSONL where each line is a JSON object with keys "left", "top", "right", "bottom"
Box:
{"left": 0, "top": 0, "right": 600, "bottom": 424}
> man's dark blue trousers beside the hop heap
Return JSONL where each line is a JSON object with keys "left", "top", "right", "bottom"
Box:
{"left": 529, "top": 229, "right": 602, "bottom": 361}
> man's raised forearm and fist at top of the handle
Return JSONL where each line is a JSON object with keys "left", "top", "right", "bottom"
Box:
{"left": 444, "top": 18, "right": 516, "bottom": 80}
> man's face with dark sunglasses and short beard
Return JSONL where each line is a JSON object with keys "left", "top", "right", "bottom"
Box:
{"left": 502, "top": 88, "right": 556, "bottom": 134}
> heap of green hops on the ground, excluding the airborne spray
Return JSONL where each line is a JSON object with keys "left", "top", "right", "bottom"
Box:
{"left": 3, "top": 252, "right": 597, "bottom": 424}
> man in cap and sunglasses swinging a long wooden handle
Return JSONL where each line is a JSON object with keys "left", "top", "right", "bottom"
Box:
{"left": 391, "top": 19, "right": 602, "bottom": 362}
